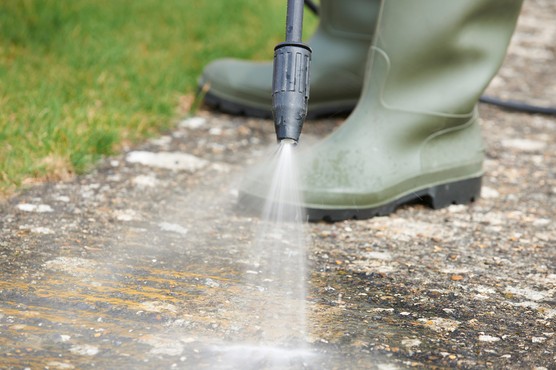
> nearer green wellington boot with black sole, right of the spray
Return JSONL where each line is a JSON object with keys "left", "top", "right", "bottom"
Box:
{"left": 242, "top": 0, "right": 522, "bottom": 221}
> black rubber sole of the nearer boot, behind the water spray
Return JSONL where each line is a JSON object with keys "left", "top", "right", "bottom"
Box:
{"left": 238, "top": 176, "right": 482, "bottom": 222}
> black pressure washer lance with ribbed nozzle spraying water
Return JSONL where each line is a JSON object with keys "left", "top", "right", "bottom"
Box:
{"left": 272, "top": 0, "right": 311, "bottom": 144}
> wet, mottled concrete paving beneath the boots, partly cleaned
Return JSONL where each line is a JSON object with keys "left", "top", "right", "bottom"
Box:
{"left": 0, "top": 0, "right": 556, "bottom": 370}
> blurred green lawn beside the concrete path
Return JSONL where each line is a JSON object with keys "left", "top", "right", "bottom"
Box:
{"left": 0, "top": 0, "right": 316, "bottom": 196}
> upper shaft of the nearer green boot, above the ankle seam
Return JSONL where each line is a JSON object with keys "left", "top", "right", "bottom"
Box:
{"left": 366, "top": 0, "right": 523, "bottom": 116}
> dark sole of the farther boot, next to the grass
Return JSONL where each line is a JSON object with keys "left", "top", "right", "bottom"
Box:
{"left": 204, "top": 91, "right": 355, "bottom": 120}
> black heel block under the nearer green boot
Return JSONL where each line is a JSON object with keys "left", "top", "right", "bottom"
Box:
{"left": 428, "top": 177, "right": 482, "bottom": 209}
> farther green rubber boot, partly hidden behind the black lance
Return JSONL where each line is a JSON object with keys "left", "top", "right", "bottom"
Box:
{"left": 199, "top": 0, "right": 380, "bottom": 118}
